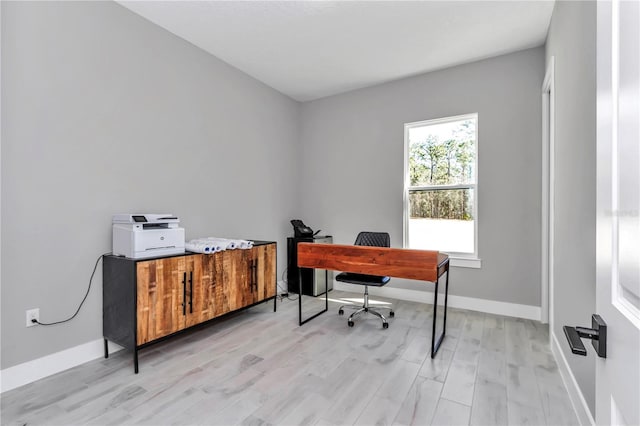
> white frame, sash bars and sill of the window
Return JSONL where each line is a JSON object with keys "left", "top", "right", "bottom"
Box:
{"left": 402, "top": 113, "right": 482, "bottom": 268}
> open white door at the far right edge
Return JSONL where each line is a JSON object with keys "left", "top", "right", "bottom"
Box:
{"left": 591, "top": 0, "right": 640, "bottom": 425}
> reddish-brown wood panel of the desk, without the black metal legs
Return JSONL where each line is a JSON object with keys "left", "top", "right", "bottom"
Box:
{"left": 298, "top": 243, "right": 447, "bottom": 282}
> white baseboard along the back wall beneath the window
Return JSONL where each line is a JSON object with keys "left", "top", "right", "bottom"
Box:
{"left": 333, "top": 281, "right": 540, "bottom": 321}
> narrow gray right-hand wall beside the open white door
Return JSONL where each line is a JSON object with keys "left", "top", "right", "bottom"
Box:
{"left": 546, "top": 1, "right": 596, "bottom": 416}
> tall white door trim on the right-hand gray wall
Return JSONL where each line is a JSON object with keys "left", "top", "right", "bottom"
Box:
{"left": 540, "top": 56, "right": 555, "bottom": 328}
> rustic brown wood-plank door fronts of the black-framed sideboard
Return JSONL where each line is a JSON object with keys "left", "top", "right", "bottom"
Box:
{"left": 136, "top": 244, "right": 276, "bottom": 345}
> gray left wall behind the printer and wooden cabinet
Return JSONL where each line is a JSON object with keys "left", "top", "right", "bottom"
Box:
{"left": 1, "top": 2, "right": 299, "bottom": 369}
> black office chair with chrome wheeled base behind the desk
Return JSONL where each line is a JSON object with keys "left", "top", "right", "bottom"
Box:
{"left": 336, "top": 232, "right": 394, "bottom": 328}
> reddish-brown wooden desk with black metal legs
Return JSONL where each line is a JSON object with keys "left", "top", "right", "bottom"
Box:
{"left": 298, "top": 243, "right": 449, "bottom": 358}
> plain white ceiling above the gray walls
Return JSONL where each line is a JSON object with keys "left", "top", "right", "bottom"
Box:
{"left": 118, "top": 0, "right": 554, "bottom": 101}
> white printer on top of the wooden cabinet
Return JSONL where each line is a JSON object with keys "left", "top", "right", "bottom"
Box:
{"left": 112, "top": 214, "right": 184, "bottom": 259}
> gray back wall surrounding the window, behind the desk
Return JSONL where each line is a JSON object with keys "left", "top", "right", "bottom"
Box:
{"left": 299, "top": 47, "right": 544, "bottom": 306}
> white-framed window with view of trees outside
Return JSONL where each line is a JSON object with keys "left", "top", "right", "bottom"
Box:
{"left": 404, "top": 114, "right": 479, "bottom": 267}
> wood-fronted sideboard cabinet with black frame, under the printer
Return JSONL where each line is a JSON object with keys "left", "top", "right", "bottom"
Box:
{"left": 103, "top": 242, "right": 276, "bottom": 372}
